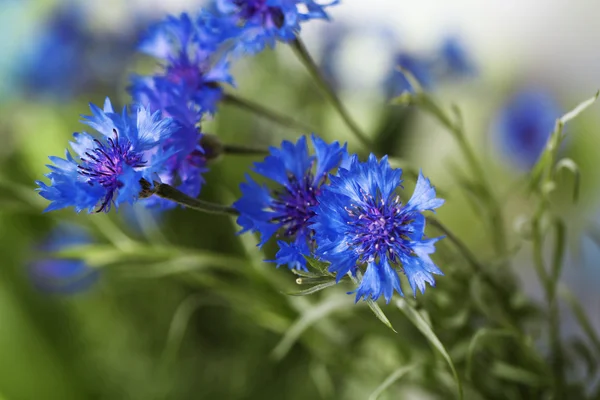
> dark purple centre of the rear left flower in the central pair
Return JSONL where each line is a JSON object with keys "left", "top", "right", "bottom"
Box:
{"left": 271, "top": 172, "right": 319, "bottom": 237}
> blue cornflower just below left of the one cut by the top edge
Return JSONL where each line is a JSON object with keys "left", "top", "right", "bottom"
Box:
{"left": 137, "top": 12, "right": 237, "bottom": 113}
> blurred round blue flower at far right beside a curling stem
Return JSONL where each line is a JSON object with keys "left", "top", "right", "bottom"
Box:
{"left": 492, "top": 88, "right": 561, "bottom": 169}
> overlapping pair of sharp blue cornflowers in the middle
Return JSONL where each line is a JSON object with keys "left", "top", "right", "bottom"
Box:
{"left": 234, "top": 136, "right": 444, "bottom": 302}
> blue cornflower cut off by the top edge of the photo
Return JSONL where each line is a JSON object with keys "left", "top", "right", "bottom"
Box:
{"left": 217, "top": 0, "right": 338, "bottom": 54}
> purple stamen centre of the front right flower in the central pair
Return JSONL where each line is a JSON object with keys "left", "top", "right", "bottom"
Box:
{"left": 345, "top": 192, "right": 412, "bottom": 262}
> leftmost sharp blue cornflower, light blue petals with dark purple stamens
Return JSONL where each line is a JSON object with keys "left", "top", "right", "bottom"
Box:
{"left": 37, "top": 99, "right": 178, "bottom": 212}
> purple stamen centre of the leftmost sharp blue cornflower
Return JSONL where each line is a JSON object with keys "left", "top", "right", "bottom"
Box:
{"left": 78, "top": 129, "right": 146, "bottom": 212}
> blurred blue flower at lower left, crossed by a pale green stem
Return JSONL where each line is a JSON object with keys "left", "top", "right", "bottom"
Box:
{"left": 29, "top": 224, "right": 100, "bottom": 294}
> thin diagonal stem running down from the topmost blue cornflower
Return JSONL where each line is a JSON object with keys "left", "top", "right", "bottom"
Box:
{"left": 290, "top": 37, "right": 372, "bottom": 149}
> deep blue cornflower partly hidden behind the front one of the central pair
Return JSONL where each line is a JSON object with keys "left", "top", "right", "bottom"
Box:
{"left": 233, "top": 135, "right": 347, "bottom": 269}
